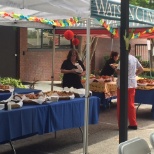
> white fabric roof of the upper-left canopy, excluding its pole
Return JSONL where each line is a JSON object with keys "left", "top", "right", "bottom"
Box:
{"left": 0, "top": 0, "right": 90, "bottom": 29}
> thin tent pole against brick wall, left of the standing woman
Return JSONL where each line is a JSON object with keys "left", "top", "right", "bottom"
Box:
{"left": 51, "top": 26, "right": 55, "bottom": 91}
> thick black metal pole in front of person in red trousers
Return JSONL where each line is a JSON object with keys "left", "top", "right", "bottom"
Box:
{"left": 119, "top": 0, "right": 129, "bottom": 143}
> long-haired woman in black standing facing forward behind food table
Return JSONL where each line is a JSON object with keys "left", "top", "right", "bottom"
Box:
{"left": 61, "top": 49, "right": 85, "bottom": 89}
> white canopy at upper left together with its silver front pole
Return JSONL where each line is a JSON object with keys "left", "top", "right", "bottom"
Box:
{"left": 0, "top": 0, "right": 91, "bottom": 153}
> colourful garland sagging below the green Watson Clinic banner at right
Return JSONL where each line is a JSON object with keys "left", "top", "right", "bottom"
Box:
{"left": 100, "top": 19, "right": 154, "bottom": 39}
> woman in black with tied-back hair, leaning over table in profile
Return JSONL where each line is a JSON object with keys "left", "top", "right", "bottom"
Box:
{"left": 100, "top": 51, "right": 119, "bottom": 76}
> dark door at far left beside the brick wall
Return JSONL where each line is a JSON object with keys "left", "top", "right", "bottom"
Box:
{"left": 0, "top": 26, "right": 18, "bottom": 78}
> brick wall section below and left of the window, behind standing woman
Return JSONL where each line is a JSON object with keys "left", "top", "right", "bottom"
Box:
{"left": 20, "top": 28, "right": 68, "bottom": 81}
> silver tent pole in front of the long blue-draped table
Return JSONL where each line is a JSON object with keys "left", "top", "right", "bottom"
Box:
{"left": 83, "top": 18, "right": 90, "bottom": 154}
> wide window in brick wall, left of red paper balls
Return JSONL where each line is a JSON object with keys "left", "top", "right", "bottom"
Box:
{"left": 27, "top": 28, "right": 71, "bottom": 49}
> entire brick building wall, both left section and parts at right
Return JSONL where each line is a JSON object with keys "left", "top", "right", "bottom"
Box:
{"left": 19, "top": 28, "right": 146, "bottom": 81}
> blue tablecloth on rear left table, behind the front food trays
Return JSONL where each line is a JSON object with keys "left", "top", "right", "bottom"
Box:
{"left": 0, "top": 88, "right": 41, "bottom": 101}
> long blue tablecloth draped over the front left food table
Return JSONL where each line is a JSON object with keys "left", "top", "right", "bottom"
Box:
{"left": 0, "top": 96, "right": 100, "bottom": 143}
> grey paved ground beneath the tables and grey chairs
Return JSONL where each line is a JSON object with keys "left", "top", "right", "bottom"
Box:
{"left": 0, "top": 81, "right": 154, "bottom": 154}
